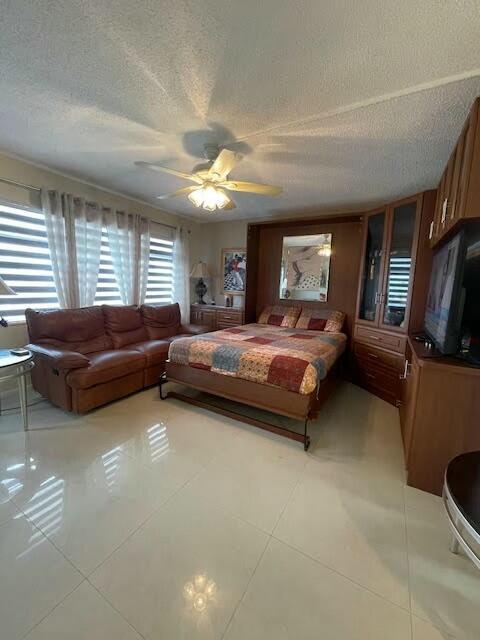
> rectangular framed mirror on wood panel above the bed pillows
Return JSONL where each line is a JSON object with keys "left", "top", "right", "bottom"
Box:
{"left": 280, "top": 233, "right": 332, "bottom": 302}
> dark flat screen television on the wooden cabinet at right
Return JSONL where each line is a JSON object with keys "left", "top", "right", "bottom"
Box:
{"left": 425, "top": 231, "right": 465, "bottom": 354}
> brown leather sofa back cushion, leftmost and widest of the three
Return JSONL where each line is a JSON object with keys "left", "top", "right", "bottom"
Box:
{"left": 25, "top": 307, "right": 112, "bottom": 354}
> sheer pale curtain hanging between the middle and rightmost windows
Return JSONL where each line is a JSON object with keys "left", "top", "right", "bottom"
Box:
{"left": 105, "top": 210, "right": 150, "bottom": 305}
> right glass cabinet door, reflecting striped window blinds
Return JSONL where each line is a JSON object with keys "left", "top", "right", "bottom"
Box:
{"left": 382, "top": 201, "right": 417, "bottom": 328}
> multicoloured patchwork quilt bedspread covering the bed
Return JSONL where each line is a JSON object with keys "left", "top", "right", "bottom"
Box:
{"left": 169, "top": 324, "right": 347, "bottom": 394}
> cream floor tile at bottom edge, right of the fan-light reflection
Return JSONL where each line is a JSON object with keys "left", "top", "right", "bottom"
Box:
{"left": 226, "top": 540, "right": 410, "bottom": 640}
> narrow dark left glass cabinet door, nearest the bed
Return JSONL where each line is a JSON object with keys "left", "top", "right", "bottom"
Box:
{"left": 358, "top": 211, "right": 385, "bottom": 322}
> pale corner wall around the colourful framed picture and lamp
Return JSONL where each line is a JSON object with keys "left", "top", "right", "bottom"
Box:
{"left": 192, "top": 220, "right": 248, "bottom": 306}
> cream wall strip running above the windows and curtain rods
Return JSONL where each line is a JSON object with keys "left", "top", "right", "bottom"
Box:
{"left": 0, "top": 154, "right": 201, "bottom": 348}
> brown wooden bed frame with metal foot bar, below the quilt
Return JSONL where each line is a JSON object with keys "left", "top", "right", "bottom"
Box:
{"left": 159, "top": 354, "right": 345, "bottom": 451}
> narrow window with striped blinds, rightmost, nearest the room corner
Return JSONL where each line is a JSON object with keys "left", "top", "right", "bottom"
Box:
{"left": 145, "top": 222, "right": 174, "bottom": 304}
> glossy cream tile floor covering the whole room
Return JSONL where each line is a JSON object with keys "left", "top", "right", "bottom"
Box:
{"left": 0, "top": 384, "right": 480, "bottom": 640}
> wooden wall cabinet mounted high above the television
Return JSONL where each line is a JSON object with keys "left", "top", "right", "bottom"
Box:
{"left": 429, "top": 99, "right": 480, "bottom": 246}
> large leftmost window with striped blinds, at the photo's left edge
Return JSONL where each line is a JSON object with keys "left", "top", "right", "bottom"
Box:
{"left": 0, "top": 204, "right": 58, "bottom": 322}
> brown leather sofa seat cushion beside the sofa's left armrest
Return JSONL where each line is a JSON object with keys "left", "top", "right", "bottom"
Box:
{"left": 66, "top": 349, "right": 145, "bottom": 389}
